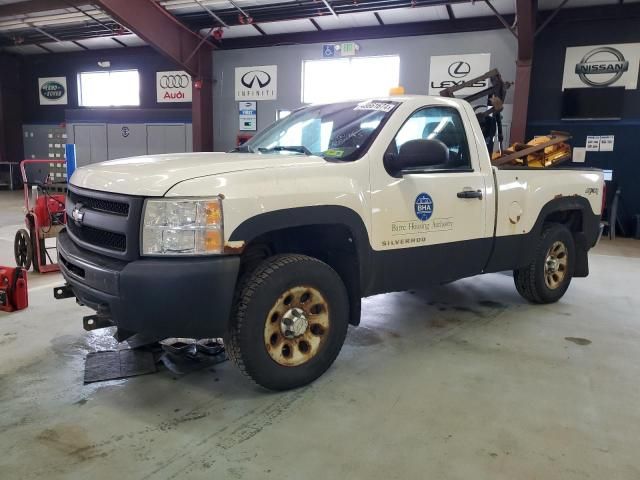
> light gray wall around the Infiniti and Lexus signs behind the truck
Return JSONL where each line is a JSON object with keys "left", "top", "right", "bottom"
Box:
{"left": 213, "top": 29, "right": 517, "bottom": 151}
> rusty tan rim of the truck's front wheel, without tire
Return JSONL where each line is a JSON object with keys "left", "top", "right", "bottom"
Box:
{"left": 264, "top": 286, "right": 330, "bottom": 367}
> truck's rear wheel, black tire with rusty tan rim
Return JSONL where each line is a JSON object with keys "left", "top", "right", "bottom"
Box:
{"left": 513, "top": 223, "right": 575, "bottom": 303}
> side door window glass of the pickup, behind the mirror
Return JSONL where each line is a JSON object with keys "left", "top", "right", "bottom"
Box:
{"left": 387, "top": 107, "right": 471, "bottom": 170}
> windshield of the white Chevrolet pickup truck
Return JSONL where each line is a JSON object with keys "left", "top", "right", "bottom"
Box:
{"left": 234, "top": 100, "right": 399, "bottom": 160}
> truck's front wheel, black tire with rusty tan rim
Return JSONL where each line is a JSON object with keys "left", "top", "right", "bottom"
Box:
{"left": 225, "top": 254, "right": 349, "bottom": 390}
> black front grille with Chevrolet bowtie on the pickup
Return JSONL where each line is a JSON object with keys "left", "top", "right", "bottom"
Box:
{"left": 66, "top": 185, "right": 144, "bottom": 260}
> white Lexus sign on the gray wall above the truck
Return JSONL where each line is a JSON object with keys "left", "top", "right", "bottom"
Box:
{"left": 429, "top": 53, "right": 491, "bottom": 95}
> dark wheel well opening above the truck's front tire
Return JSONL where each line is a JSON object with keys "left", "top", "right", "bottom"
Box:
{"left": 240, "top": 224, "right": 361, "bottom": 325}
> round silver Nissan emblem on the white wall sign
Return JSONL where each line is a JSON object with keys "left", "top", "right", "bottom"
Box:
{"left": 575, "top": 47, "right": 629, "bottom": 87}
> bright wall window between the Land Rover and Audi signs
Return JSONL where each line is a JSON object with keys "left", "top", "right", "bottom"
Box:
{"left": 78, "top": 70, "right": 140, "bottom": 107}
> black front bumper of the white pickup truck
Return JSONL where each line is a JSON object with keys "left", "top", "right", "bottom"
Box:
{"left": 58, "top": 231, "right": 240, "bottom": 338}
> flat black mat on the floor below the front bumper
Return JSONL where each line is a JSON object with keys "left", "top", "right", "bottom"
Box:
{"left": 84, "top": 350, "right": 157, "bottom": 385}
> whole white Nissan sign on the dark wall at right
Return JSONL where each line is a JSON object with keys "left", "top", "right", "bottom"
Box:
{"left": 562, "top": 43, "right": 640, "bottom": 90}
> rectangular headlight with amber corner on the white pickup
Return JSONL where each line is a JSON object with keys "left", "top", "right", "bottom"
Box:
{"left": 141, "top": 197, "right": 224, "bottom": 255}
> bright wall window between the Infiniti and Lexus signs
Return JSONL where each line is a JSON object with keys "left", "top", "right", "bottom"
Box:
{"left": 302, "top": 56, "right": 400, "bottom": 103}
